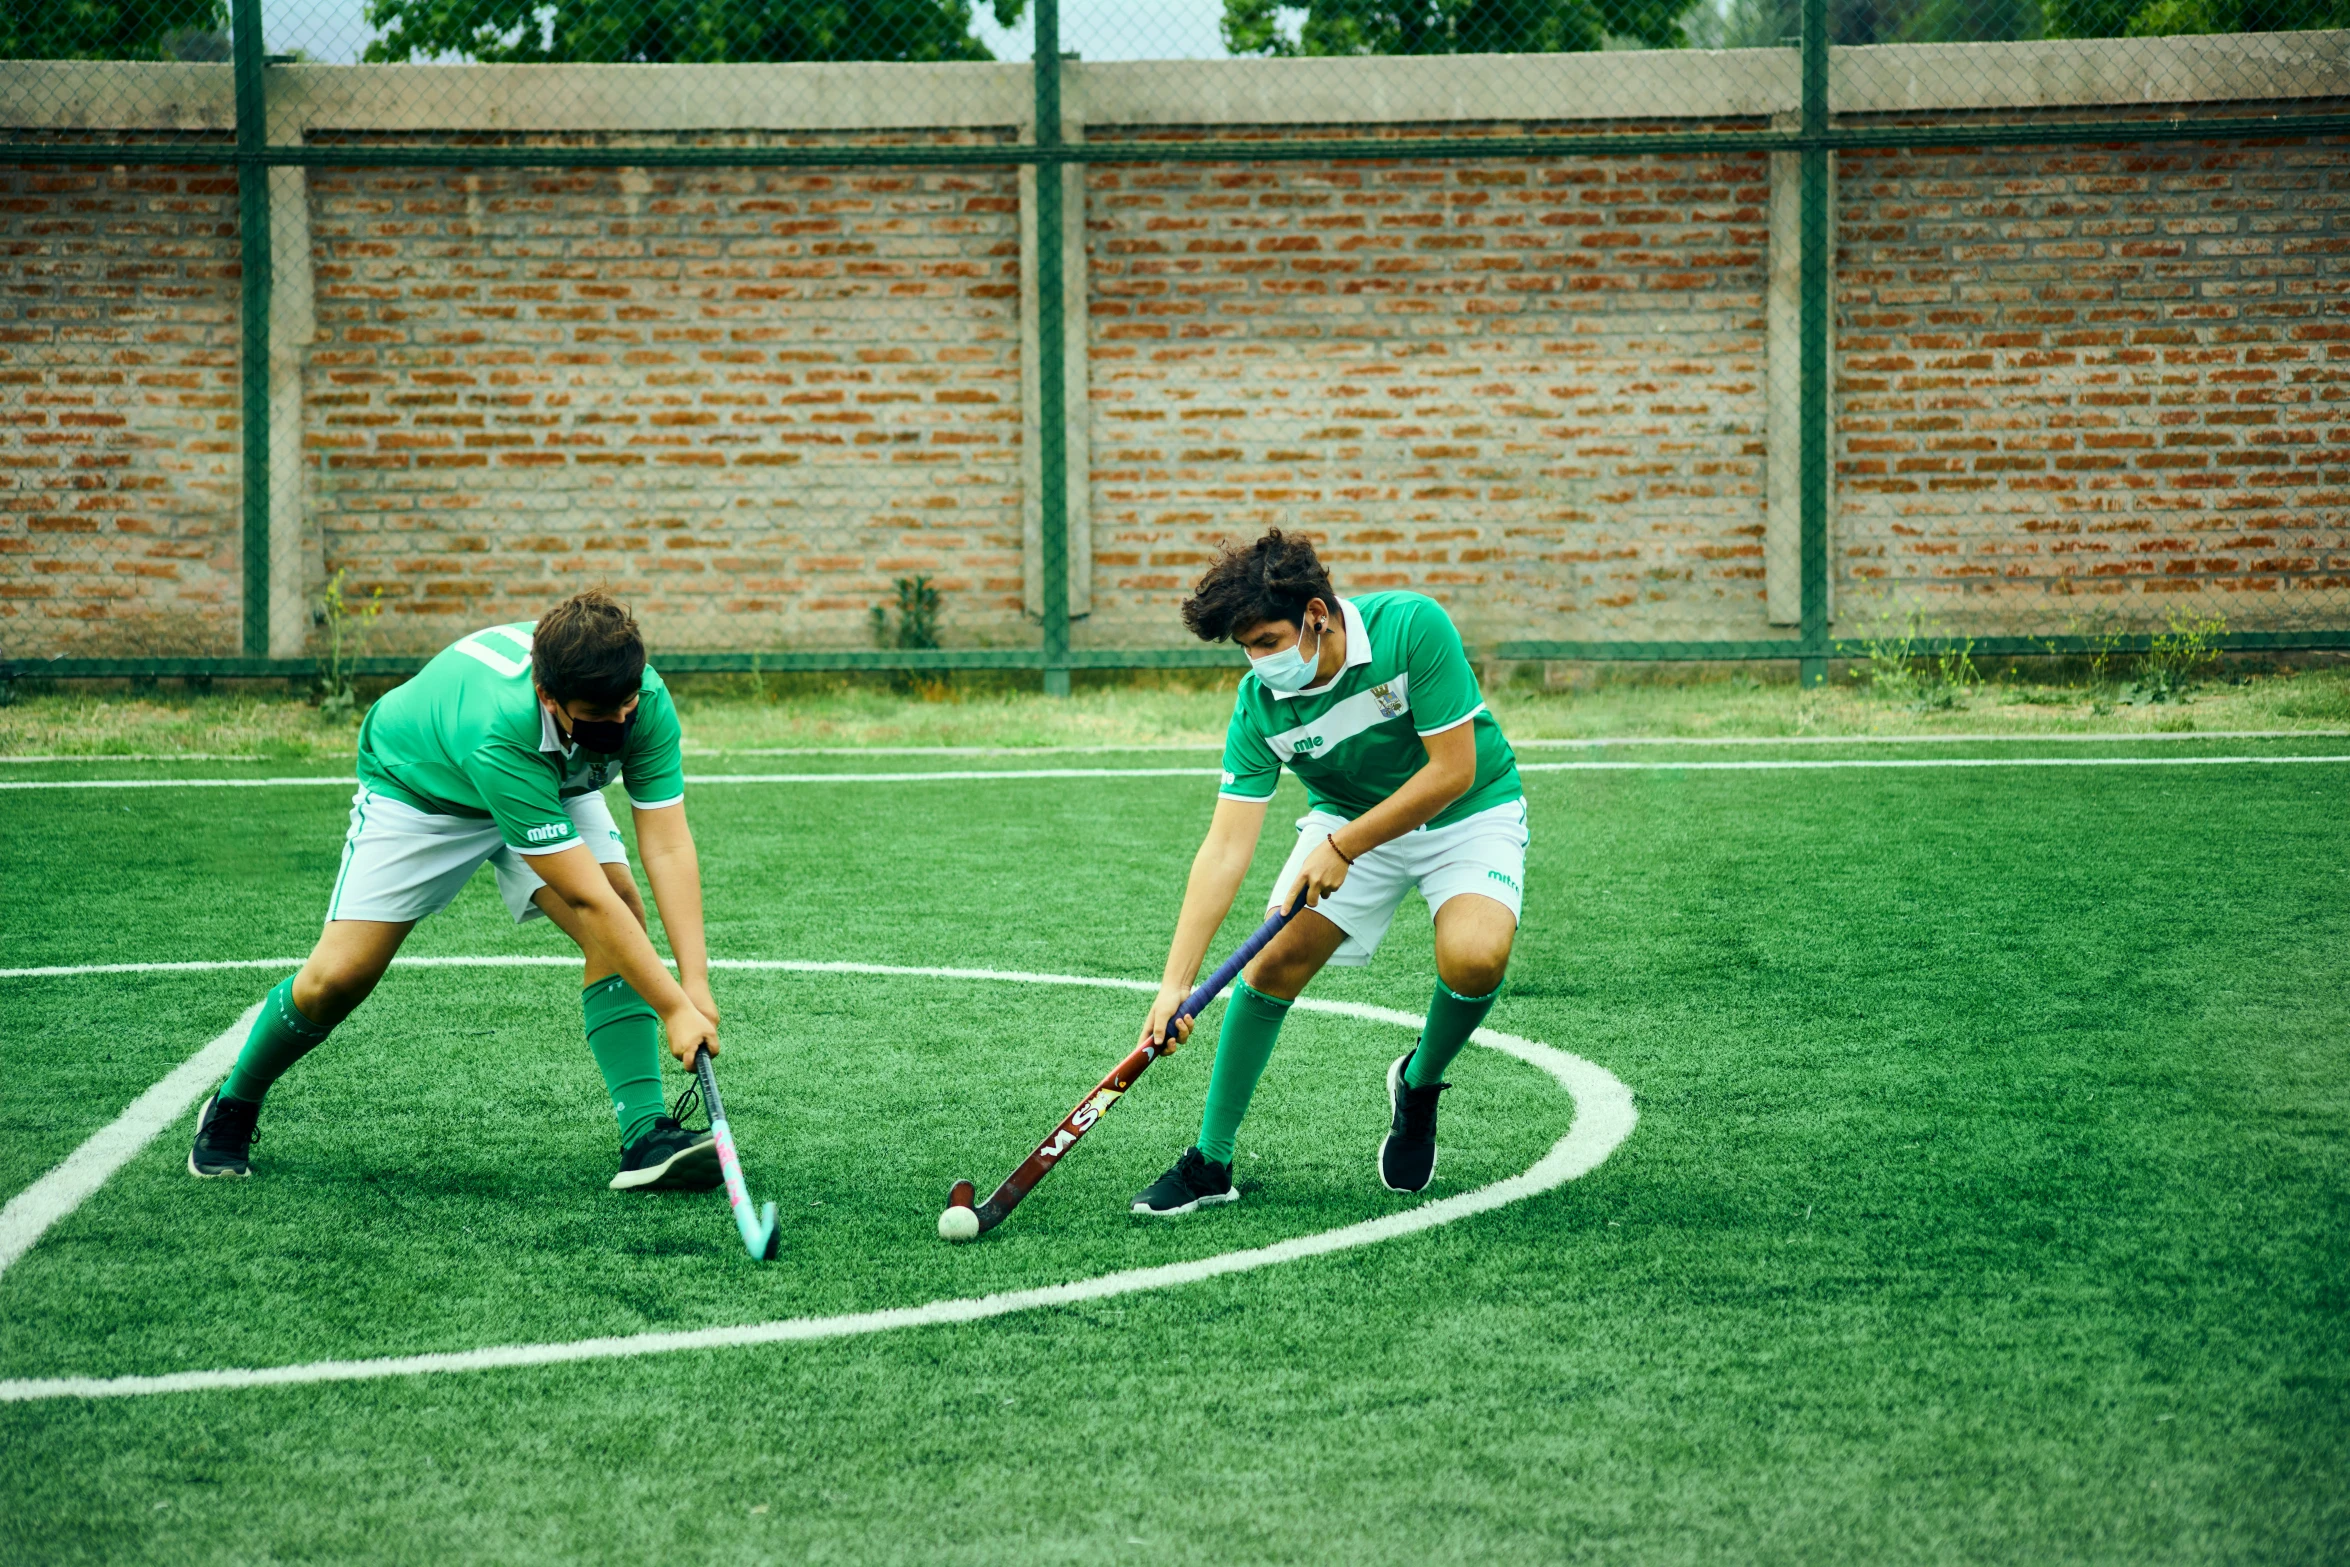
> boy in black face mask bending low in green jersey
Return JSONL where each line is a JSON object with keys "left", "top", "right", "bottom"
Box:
{"left": 188, "top": 592, "right": 719, "bottom": 1191}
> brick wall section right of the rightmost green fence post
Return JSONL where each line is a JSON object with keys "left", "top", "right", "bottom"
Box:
{"left": 1835, "top": 141, "right": 2350, "bottom": 632}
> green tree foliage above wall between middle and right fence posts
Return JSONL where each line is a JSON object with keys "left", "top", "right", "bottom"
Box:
{"left": 1224, "top": 0, "right": 1704, "bottom": 54}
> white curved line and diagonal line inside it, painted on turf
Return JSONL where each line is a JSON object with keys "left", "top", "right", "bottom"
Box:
{"left": 0, "top": 956, "right": 1640, "bottom": 1403}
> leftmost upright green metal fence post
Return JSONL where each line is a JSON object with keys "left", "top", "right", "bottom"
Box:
{"left": 230, "top": 0, "right": 270, "bottom": 658}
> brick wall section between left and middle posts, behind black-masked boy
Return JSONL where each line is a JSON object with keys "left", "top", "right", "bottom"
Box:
{"left": 306, "top": 151, "right": 1025, "bottom": 648}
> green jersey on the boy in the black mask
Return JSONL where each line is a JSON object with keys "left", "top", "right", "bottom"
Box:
{"left": 360, "top": 620, "right": 686, "bottom": 855}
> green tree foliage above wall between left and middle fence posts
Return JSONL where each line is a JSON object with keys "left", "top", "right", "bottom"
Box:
{"left": 367, "top": 0, "right": 1027, "bottom": 63}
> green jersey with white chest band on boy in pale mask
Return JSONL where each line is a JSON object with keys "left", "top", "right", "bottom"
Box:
{"left": 1220, "top": 592, "right": 1525, "bottom": 827}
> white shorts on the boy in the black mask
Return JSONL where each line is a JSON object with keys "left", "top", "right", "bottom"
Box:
{"left": 327, "top": 787, "right": 627, "bottom": 926}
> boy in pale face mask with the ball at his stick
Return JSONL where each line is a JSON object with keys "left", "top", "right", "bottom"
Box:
{"left": 1133, "top": 529, "right": 1525, "bottom": 1215}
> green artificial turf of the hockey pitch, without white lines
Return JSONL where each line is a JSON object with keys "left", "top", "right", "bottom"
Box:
{"left": 0, "top": 742, "right": 2350, "bottom": 1565}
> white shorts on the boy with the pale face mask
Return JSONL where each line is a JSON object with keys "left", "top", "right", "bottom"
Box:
{"left": 1264, "top": 799, "right": 1525, "bottom": 968}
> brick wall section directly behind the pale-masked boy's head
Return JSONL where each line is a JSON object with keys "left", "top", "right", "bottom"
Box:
{"left": 1086, "top": 138, "right": 1770, "bottom": 644}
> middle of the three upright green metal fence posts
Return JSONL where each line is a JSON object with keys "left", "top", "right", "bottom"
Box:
{"left": 1032, "top": 0, "right": 1069, "bottom": 695}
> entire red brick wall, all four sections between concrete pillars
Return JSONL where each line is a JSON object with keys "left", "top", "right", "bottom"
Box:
{"left": 0, "top": 132, "right": 2350, "bottom": 655}
